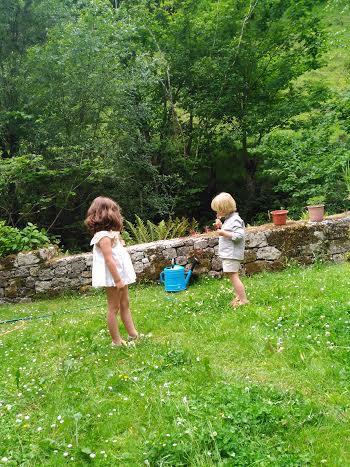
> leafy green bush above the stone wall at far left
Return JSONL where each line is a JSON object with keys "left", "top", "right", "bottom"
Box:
{"left": 0, "top": 221, "right": 52, "bottom": 256}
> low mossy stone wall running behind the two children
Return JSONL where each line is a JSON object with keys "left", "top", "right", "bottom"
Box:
{"left": 0, "top": 213, "right": 350, "bottom": 304}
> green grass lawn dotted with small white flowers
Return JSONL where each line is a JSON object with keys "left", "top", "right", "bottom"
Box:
{"left": 0, "top": 263, "right": 350, "bottom": 467}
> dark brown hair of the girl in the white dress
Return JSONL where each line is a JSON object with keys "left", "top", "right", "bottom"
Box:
{"left": 85, "top": 196, "right": 123, "bottom": 235}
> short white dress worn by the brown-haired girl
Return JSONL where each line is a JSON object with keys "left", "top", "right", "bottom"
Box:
{"left": 90, "top": 230, "right": 136, "bottom": 287}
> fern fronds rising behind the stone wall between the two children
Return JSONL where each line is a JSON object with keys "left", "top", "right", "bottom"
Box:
{"left": 124, "top": 216, "right": 198, "bottom": 243}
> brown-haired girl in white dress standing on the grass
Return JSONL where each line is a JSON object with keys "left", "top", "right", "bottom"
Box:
{"left": 85, "top": 196, "right": 138, "bottom": 346}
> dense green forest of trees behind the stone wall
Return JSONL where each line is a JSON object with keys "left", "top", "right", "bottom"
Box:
{"left": 0, "top": 0, "right": 350, "bottom": 250}
